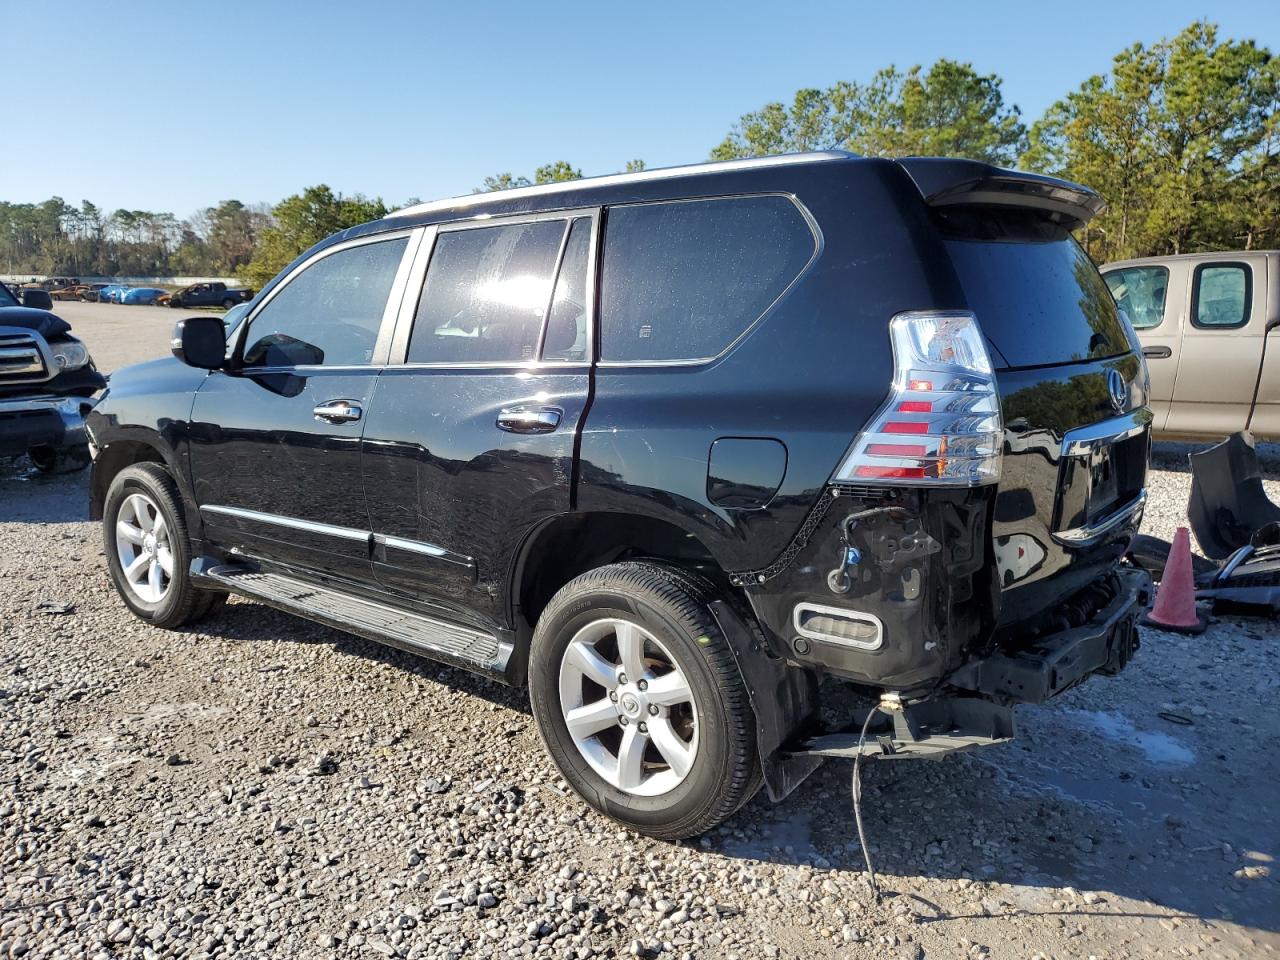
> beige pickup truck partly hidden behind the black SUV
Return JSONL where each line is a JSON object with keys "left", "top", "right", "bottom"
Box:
{"left": 1100, "top": 250, "right": 1280, "bottom": 440}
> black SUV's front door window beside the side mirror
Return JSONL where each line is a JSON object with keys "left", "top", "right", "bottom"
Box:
{"left": 244, "top": 238, "right": 408, "bottom": 366}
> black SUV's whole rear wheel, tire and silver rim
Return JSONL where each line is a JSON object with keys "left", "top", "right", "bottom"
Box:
{"left": 529, "top": 562, "right": 759, "bottom": 840}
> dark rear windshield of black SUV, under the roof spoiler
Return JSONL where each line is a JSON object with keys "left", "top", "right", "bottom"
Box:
{"left": 946, "top": 221, "right": 1130, "bottom": 367}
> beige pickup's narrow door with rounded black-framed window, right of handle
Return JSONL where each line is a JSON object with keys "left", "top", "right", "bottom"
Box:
{"left": 1165, "top": 253, "right": 1267, "bottom": 436}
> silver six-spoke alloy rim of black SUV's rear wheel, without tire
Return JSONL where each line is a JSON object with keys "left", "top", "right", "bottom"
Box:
{"left": 559, "top": 617, "right": 698, "bottom": 796}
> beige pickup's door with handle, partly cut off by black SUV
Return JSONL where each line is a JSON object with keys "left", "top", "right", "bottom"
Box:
{"left": 1102, "top": 260, "right": 1189, "bottom": 430}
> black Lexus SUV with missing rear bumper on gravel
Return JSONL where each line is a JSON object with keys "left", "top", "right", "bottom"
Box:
{"left": 88, "top": 154, "right": 1149, "bottom": 837}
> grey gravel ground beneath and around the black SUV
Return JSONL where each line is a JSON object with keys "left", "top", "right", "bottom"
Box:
{"left": 0, "top": 321, "right": 1280, "bottom": 960}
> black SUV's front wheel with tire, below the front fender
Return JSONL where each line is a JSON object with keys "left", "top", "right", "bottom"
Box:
{"left": 102, "top": 463, "right": 225, "bottom": 628}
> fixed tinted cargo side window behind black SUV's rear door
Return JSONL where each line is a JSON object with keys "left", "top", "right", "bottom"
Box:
{"left": 600, "top": 197, "right": 814, "bottom": 361}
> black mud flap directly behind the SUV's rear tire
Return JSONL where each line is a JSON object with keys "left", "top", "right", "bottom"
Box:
{"left": 709, "top": 600, "right": 823, "bottom": 803}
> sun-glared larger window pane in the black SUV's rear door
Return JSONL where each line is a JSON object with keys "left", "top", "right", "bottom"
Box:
{"left": 408, "top": 220, "right": 566, "bottom": 364}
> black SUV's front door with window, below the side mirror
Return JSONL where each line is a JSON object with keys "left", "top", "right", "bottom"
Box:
{"left": 191, "top": 233, "right": 419, "bottom": 582}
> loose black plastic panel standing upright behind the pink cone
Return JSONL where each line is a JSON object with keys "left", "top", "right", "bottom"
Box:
{"left": 1187, "top": 431, "right": 1280, "bottom": 559}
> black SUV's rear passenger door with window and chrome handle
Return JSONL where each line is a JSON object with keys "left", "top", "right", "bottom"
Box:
{"left": 361, "top": 209, "right": 599, "bottom": 628}
